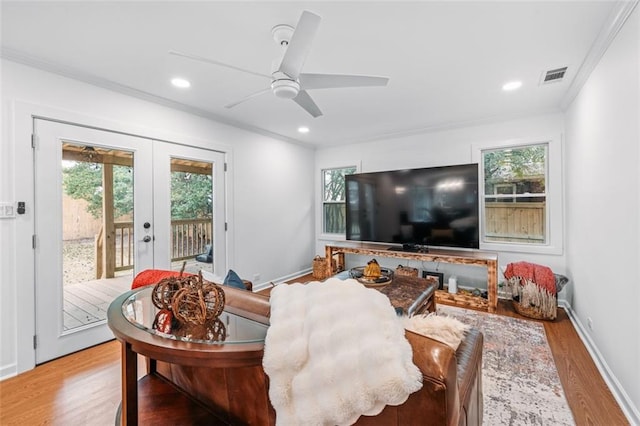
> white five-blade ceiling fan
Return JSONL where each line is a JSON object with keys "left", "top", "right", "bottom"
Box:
{"left": 169, "top": 11, "right": 389, "bottom": 118}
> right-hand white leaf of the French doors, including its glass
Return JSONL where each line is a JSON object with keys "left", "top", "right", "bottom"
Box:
{"left": 153, "top": 141, "right": 227, "bottom": 277}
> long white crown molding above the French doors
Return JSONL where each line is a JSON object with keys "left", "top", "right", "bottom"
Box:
{"left": 0, "top": 47, "right": 310, "bottom": 148}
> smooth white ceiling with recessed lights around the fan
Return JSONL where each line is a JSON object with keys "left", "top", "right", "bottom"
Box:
{"left": 2, "top": 1, "right": 620, "bottom": 146}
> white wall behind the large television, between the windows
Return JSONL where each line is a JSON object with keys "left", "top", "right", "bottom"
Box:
{"left": 316, "top": 113, "right": 566, "bottom": 290}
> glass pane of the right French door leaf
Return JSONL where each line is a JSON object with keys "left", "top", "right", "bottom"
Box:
{"left": 171, "top": 158, "right": 215, "bottom": 273}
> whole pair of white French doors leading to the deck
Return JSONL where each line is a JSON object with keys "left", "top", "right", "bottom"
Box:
{"left": 34, "top": 119, "right": 226, "bottom": 363}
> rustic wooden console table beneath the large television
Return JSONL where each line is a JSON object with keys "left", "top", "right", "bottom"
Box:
{"left": 325, "top": 242, "right": 498, "bottom": 313}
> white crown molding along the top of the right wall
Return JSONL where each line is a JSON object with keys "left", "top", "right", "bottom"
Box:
{"left": 560, "top": 0, "right": 640, "bottom": 111}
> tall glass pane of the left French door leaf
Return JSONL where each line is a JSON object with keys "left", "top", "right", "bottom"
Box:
{"left": 62, "top": 142, "right": 134, "bottom": 333}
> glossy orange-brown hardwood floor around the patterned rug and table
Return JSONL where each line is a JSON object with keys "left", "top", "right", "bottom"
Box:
{"left": 0, "top": 276, "right": 629, "bottom": 426}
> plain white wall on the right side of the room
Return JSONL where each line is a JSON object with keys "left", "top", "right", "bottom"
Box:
{"left": 566, "top": 4, "right": 640, "bottom": 424}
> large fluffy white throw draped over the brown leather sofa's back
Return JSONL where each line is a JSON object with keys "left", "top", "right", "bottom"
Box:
{"left": 263, "top": 278, "right": 422, "bottom": 425}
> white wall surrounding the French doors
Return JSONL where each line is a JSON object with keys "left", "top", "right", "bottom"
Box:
{"left": 0, "top": 60, "right": 315, "bottom": 377}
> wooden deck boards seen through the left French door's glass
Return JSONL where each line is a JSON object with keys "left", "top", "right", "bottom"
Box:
{"left": 64, "top": 274, "right": 132, "bottom": 331}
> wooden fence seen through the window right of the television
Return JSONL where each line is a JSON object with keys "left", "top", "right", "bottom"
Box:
{"left": 484, "top": 202, "right": 546, "bottom": 243}
